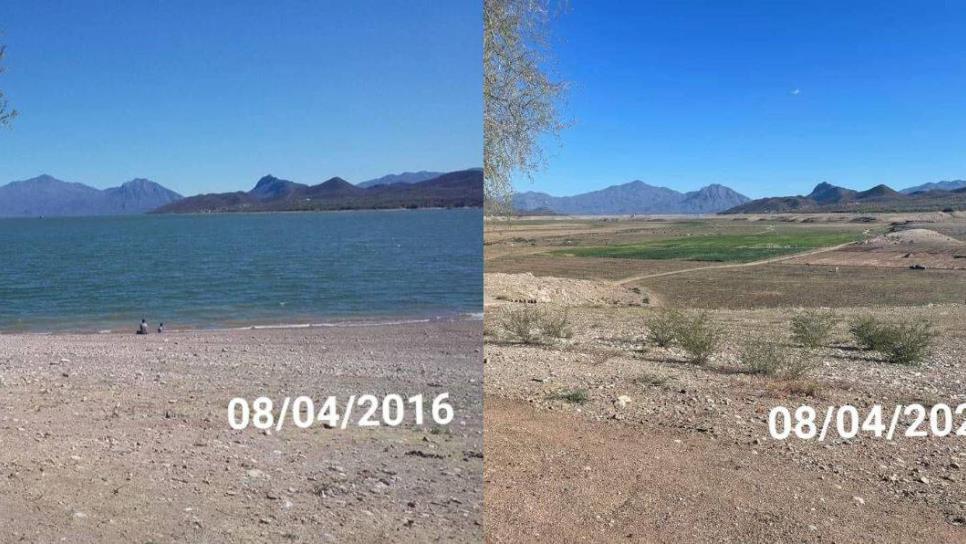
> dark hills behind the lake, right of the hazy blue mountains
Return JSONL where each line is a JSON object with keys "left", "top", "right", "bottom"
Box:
{"left": 153, "top": 168, "right": 483, "bottom": 213}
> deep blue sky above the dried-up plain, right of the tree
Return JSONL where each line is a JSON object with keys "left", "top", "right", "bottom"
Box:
{"left": 518, "top": 0, "right": 966, "bottom": 197}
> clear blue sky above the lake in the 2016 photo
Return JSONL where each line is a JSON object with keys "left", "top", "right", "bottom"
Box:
{"left": 0, "top": 0, "right": 483, "bottom": 194}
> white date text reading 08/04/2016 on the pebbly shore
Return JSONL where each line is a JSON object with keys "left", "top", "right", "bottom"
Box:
{"left": 228, "top": 393, "right": 456, "bottom": 431}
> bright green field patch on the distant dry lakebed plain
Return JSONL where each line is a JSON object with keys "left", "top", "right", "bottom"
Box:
{"left": 554, "top": 231, "right": 860, "bottom": 262}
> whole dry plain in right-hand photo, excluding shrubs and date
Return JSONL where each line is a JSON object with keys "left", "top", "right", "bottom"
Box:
{"left": 484, "top": 212, "right": 966, "bottom": 543}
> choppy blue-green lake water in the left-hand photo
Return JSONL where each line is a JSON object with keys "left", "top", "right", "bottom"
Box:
{"left": 0, "top": 209, "right": 483, "bottom": 332}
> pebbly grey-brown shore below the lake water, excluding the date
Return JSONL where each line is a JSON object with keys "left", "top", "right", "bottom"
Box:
{"left": 0, "top": 321, "right": 483, "bottom": 543}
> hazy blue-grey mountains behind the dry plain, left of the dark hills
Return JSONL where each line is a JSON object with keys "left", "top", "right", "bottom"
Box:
{"left": 513, "top": 180, "right": 750, "bottom": 215}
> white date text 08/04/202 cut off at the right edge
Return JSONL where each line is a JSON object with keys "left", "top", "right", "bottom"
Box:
{"left": 768, "top": 403, "right": 966, "bottom": 442}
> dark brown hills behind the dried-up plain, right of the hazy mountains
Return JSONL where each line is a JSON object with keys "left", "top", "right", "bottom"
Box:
{"left": 723, "top": 182, "right": 966, "bottom": 214}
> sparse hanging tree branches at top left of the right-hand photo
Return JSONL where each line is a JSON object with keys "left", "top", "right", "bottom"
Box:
{"left": 483, "top": 0, "right": 566, "bottom": 212}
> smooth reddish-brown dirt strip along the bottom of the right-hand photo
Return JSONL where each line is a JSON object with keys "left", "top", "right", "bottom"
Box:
{"left": 484, "top": 397, "right": 966, "bottom": 543}
